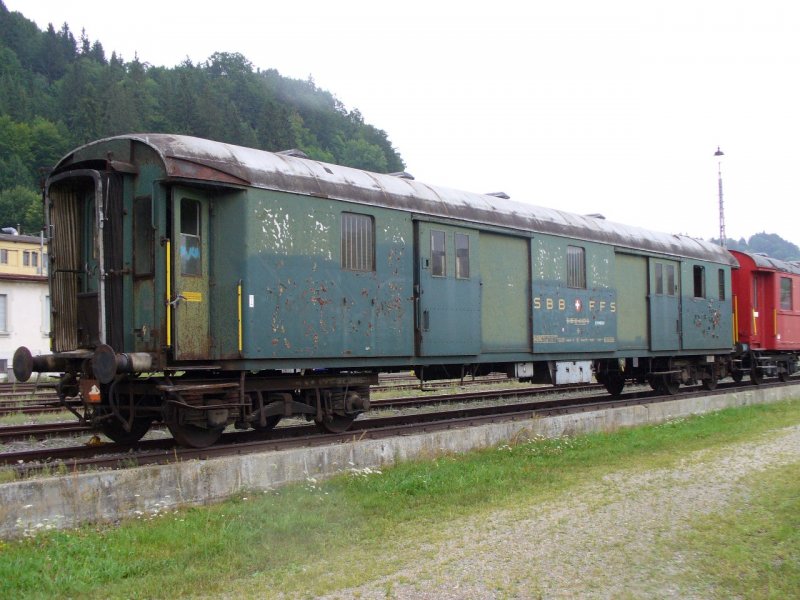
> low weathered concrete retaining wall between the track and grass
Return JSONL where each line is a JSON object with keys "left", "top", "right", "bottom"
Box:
{"left": 0, "top": 385, "right": 800, "bottom": 537}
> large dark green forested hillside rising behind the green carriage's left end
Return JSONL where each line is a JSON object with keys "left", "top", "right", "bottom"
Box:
{"left": 0, "top": 0, "right": 404, "bottom": 232}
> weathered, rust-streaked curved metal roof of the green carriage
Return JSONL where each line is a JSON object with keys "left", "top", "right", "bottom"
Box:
{"left": 56, "top": 134, "right": 737, "bottom": 266}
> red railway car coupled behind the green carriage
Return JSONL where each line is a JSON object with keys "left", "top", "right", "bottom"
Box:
{"left": 731, "top": 250, "right": 800, "bottom": 383}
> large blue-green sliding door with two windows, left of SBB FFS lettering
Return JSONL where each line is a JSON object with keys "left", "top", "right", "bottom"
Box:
{"left": 415, "top": 221, "right": 481, "bottom": 356}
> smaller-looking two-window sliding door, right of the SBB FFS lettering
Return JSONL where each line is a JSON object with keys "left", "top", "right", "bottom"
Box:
{"left": 648, "top": 259, "right": 681, "bottom": 351}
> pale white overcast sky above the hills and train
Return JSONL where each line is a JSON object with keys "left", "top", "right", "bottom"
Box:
{"left": 4, "top": 0, "right": 800, "bottom": 244}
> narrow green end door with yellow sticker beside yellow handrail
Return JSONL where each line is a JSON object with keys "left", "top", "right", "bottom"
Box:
{"left": 170, "top": 188, "right": 210, "bottom": 360}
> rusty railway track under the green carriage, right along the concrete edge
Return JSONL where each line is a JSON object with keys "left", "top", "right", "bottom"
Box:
{"left": 0, "top": 379, "right": 798, "bottom": 477}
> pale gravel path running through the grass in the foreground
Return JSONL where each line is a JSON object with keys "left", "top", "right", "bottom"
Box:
{"left": 322, "top": 426, "right": 800, "bottom": 599}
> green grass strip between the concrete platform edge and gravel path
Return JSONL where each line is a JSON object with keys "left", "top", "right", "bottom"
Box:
{"left": 0, "top": 401, "right": 800, "bottom": 598}
